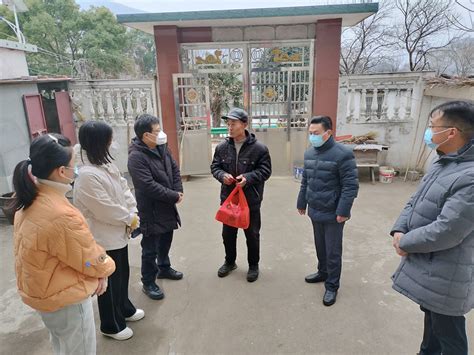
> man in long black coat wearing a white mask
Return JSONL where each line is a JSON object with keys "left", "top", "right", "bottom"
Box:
{"left": 128, "top": 114, "right": 183, "bottom": 300}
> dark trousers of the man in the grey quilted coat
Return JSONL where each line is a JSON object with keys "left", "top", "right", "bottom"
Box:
{"left": 420, "top": 307, "right": 467, "bottom": 355}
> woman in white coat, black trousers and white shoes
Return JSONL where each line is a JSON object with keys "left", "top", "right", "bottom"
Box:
{"left": 73, "top": 121, "right": 145, "bottom": 340}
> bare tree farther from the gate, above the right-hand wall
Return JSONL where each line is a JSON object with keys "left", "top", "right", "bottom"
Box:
{"left": 396, "top": 0, "right": 456, "bottom": 71}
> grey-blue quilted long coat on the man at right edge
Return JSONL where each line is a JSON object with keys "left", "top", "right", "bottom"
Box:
{"left": 391, "top": 142, "right": 474, "bottom": 316}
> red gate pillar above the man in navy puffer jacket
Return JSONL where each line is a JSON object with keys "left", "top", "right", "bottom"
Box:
{"left": 313, "top": 19, "right": 342, "bottom": 135}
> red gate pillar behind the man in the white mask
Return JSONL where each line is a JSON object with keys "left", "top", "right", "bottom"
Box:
{"left": 153, "top": 26, "right": 180, "bottom": 164}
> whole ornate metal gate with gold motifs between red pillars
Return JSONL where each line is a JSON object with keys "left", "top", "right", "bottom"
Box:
{"left": 174, "top": 40, "right": 314, "bottom": 174}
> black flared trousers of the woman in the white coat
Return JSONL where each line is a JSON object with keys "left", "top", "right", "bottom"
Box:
{"left": 97, "top": 246, "right": 136, "bottom": 334}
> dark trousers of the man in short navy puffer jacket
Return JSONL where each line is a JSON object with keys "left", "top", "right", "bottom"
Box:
{"left": 311, "top": 220, "right": 344, "bottom": 291}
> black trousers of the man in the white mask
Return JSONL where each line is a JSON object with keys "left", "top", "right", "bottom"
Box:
{"left": 141, "top": 231, "right": 173, "bottom": 285}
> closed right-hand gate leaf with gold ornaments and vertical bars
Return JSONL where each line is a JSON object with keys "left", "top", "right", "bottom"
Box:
{"left": 249, "top": 41, "right": 314, "bottom": 128}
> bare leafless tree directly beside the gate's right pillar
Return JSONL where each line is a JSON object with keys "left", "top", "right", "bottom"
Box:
{"left": 340, "top": 1, "right": 396, "bottom": 74}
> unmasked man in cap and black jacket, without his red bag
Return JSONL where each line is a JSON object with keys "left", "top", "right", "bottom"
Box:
{"left": 211, "top": 108, "right": 272, "bottom": 282}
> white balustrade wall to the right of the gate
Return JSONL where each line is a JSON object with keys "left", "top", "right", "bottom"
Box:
{"left": 337, "top": 73, "right": 433, "bottom": 171}
